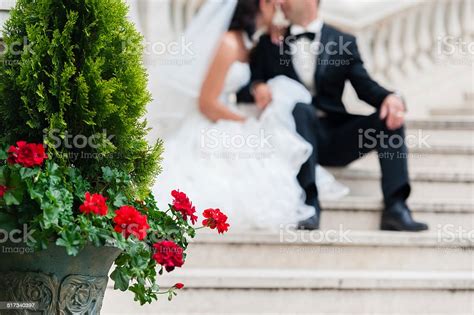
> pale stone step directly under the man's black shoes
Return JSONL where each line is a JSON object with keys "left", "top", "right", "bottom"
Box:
{"left": 180, "top": 231, "right": 474, "bottom": 272}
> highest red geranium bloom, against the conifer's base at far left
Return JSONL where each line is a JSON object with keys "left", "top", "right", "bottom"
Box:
{"left": 8, "top": 141, "right": 48, "bottom": 167}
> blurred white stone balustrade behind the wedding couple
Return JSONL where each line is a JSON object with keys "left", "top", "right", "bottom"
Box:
{"left": 0, "top": 0, "right": 474, "bottom": 116}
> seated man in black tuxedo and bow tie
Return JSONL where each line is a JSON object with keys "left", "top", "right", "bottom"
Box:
{"left": 251, "top": 0, "right": 428, "bottom": 231}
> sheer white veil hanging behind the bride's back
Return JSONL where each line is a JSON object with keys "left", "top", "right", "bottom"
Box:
{"left": 139, "top": 0, "right": 237, "bottom": 140}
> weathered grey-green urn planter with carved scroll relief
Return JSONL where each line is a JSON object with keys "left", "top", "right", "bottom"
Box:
{"left": 0, "top": 243, "right": 121, "bottom": 315}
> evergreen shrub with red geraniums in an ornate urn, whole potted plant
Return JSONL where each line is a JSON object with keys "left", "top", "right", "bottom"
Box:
{"left": 0, "top": 0, "right": 229, "bottom": 315}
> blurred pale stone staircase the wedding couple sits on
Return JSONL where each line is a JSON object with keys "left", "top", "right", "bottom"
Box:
{"left": 102, "top": 116, "right": 474, "bottom": 315}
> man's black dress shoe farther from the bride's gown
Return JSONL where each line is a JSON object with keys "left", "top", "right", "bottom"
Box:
{"left": 380, "top": 201, "right": 428, "bottom": 232}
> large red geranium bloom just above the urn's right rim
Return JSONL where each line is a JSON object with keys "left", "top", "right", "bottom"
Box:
{"left": 114, "top": 206, "right": 150, "bottom": 241}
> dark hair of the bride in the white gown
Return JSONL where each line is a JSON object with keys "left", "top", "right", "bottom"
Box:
{"left": 229, "top": 0, "right": 260, "bottom": 36}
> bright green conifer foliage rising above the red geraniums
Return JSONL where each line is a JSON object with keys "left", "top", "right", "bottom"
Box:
{"left": 0, "top": 0, "right": 161, "bottom": 194}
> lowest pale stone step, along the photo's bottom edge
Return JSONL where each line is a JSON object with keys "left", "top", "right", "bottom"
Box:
{"left": 102, "top": 268, "right": 474, "bottom": 315}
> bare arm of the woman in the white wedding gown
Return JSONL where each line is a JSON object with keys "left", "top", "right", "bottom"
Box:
{"left": 199, "top": 35, "right": 245, "bottom": 121}
